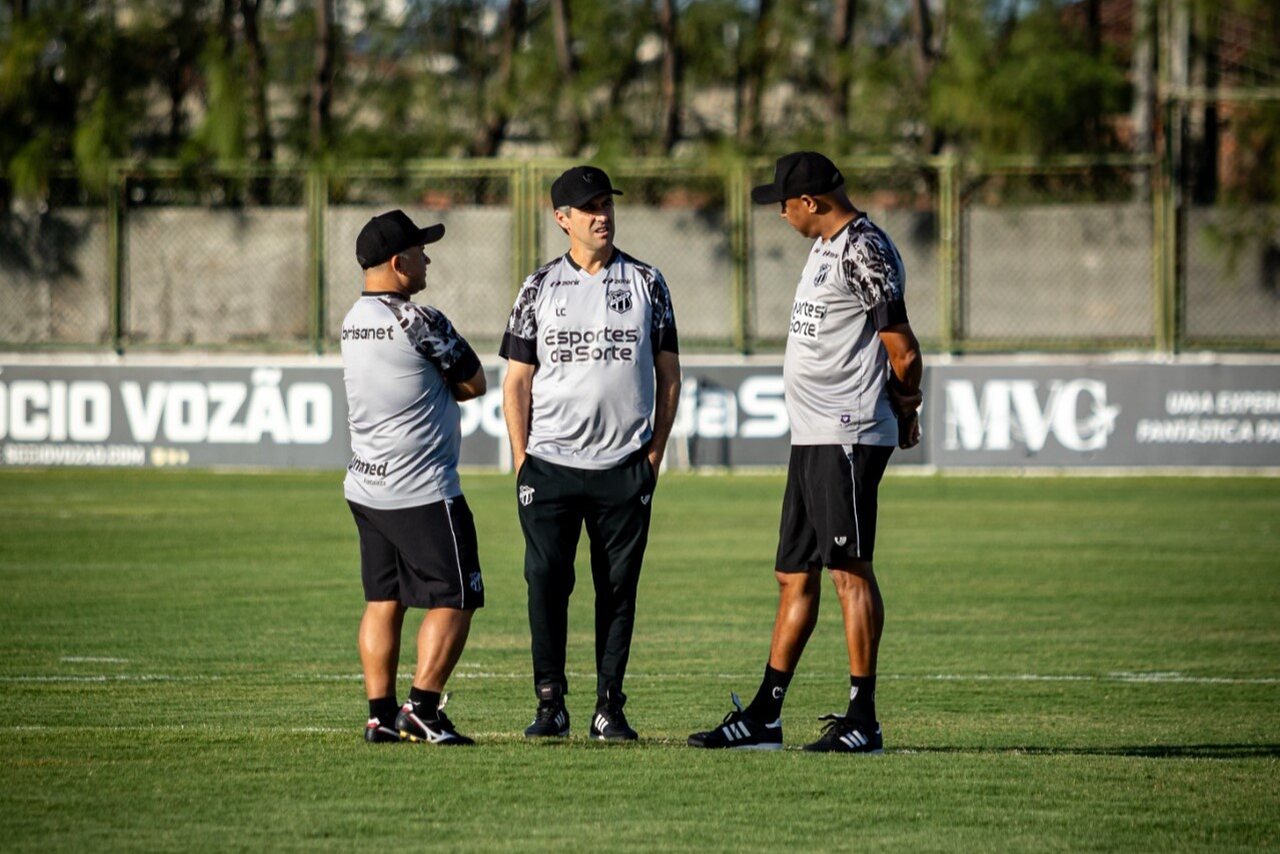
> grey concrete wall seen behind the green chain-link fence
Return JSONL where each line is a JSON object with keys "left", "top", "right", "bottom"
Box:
{"left": 0, "top": 205, "right": 1280, "bottom": 352}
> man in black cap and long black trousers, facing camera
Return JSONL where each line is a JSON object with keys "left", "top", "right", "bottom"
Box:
{"left": 500, "top": 166, "right": 680, "bottom": 741}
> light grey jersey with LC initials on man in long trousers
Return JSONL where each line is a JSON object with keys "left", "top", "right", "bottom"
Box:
{"left": 499, "top": 250, "right": 680, "bottom": 470}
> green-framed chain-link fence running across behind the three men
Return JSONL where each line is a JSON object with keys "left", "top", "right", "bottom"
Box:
{"left": 0, "top": 159, "right": 1280, "bottom": 353}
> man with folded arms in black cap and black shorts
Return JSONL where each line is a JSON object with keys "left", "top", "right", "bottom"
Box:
{"left": 342, "top": 210, "right": 485, "bottom": 745}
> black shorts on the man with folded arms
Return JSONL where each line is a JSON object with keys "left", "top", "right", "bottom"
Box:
{"left": 347, "top": 495, "right": 484, "bottom": 611}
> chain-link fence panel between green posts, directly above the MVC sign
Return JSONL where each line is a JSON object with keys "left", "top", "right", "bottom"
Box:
{"left": 955, "top": 165, "right": 1157, "bottom": 348}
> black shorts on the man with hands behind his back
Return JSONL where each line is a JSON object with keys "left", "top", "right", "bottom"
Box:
{"left": 774, "top": 444, "right": 893, "bottom": 572}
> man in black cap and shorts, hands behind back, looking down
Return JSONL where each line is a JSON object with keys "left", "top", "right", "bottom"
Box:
{"left": 689, "top": 151, "right": 923, "bottom": 753}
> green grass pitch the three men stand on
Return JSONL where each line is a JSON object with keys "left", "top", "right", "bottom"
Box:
{"left": 0, "top": 471, "right": 1280, "bottom": 850}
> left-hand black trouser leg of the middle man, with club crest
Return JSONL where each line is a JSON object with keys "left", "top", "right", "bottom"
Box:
{"left": 517, "top": 457, "right": 582, "bottom": 690}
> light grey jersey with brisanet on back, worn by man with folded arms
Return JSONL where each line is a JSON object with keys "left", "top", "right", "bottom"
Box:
{"left": 342, "top": 292, "right": 480, "bottom": 510}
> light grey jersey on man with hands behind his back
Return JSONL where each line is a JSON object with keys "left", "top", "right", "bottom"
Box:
{"left": 782, "top": 215, "right": 908, "bottom": 446}
